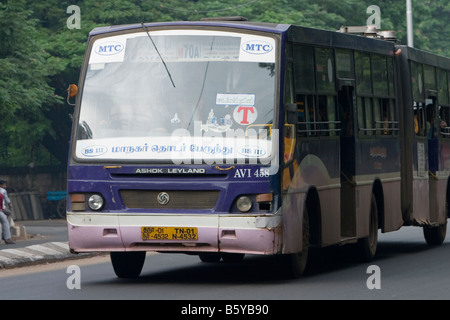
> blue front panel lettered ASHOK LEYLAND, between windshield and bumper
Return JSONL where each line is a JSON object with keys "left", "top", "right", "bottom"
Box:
{"left": 68, "top": 165, "right": 277, "bottom": 213}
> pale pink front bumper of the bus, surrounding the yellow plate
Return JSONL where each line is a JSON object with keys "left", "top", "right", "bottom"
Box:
{"left": 67, "top": 212, "right": 282, "bottom": 254}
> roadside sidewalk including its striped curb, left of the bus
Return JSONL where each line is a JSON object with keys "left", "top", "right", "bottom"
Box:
{"left": 0, "top": 219, "right": 96, "bottom": 269}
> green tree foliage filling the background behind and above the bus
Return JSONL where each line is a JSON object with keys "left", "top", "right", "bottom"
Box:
{"left": 0, "top": 0, "right": 450, "bottom": 166}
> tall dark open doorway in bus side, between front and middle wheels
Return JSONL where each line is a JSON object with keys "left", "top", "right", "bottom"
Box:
{"left": 338, "top": 79, "right": 356, "bottom": 239}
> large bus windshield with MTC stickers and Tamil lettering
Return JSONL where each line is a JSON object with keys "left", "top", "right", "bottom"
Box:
{"left": 75, "top": 30, "right": 277, "bottom": 163}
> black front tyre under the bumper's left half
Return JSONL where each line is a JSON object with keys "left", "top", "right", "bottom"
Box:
{"left": 110, "top": 251, "right": 145, "bottom": 278}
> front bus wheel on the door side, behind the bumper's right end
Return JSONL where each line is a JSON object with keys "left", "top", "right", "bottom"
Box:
{"left": 282, "top": 209, "right": 309, "bottom": 279}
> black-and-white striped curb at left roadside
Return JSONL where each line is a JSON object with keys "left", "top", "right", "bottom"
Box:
{"left": 0, "top": 242, "right": 98, "bottom": 269}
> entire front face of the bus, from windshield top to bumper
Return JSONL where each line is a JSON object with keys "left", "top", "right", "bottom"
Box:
{"left": 67, "top": 26, "right": 281, "bottom": 254}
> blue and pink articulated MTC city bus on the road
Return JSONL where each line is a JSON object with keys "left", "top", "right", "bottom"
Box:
{"left": 67, "top": 18, "right": 450, "bottom": 278}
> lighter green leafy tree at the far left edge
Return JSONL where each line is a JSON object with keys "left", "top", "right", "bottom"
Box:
{"left": 0, "top": 0, "right": 61, "bottom": 166}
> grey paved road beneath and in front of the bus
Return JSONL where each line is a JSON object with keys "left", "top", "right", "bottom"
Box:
{"left": 0, "top": 227, "right": 450, "bottom": 302}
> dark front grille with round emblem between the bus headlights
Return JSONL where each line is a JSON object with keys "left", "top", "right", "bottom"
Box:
{"left": 120, "top": 190, "right": 219, "bottom": 209}
